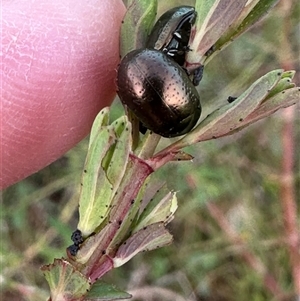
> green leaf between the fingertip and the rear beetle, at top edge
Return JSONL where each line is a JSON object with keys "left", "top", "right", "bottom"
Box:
{"left": 120, "top": 0, "right": 157, "bottom": 57}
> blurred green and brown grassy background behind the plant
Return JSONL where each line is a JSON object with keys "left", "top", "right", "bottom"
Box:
{"left": 0, "top": 0, "right": 300, "bottom": 301}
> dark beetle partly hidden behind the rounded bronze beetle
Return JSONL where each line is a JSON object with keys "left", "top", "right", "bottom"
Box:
{"left": 146, "top": 6, "right": 196, "bottom": 66}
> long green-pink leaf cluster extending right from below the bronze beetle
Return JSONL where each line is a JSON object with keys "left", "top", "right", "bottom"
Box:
{"left": 156, "top": 69, "right": 300, "bottom": 159}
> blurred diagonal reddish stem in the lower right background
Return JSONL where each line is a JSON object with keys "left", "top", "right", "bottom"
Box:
{"left": 207, "top": 203, "right": 285, "bottom": 300}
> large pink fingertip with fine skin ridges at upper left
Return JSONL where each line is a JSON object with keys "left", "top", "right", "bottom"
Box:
{"left": 0, "top": 0, "right": 125, "bottom": 188}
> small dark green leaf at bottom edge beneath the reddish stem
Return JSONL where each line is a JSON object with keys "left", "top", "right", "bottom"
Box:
{"left": 84, "top": 281, "right": 132, "bottom": 301}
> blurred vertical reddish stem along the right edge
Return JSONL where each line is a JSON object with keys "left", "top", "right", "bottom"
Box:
{"left": 278, "top": 1, "right": 300, "bottom": 299}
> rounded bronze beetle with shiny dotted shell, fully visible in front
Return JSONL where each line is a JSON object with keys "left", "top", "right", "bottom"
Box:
{"left": 117, "top": 49, "right": 201, "bottom": 137}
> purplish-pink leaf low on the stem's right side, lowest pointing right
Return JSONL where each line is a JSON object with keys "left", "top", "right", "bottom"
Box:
{"left": 113, "top": 222, "right": 173, "bottom": 267}
